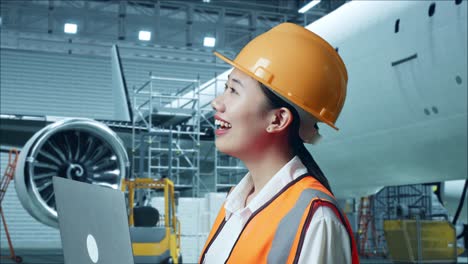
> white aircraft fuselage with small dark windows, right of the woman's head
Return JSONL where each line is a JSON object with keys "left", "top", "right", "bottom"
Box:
{"left": 306, "top": 1, "right": 468, "bottom": 197}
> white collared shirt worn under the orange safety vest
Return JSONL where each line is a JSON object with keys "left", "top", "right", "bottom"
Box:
{"left": 204, "top": 156, "right": 351, "bottom": 264}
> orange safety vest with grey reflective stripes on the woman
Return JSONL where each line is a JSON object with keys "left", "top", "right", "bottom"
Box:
{"left": 199, "top": 175, "right": 359, "bottom": 264}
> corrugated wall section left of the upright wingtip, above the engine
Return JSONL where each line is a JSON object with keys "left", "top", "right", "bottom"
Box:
{"left": 0, "top": 49, "right": 112, "bottom": 119}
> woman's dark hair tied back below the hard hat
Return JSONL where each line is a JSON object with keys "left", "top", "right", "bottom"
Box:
{"left": 259, "top": 82, "right": 332, "bottom": 195}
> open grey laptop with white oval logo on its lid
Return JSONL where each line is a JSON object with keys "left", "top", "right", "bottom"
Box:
{"left": 52, "top": 177, "right": 134, "bottom": 264}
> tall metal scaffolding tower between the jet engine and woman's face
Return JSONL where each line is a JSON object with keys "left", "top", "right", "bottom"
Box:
{"left": 131, "top": 74, "right": 205, "bottom": 197}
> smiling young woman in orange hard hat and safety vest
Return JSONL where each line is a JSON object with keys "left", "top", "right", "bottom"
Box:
{"left": 200, "top": 23, "right": 359, "bottom": 263}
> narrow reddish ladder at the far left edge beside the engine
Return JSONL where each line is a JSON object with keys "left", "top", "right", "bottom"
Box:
{"left": 0, "top": 148, "right": 23, "bottom": 263}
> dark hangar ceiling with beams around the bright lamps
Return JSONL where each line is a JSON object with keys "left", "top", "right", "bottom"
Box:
{"left": 0, "top": 0, "right": 345, "bottom": 60}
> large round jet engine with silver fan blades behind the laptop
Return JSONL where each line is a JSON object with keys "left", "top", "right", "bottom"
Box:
{"left": 15, "top": 118, "right": 130, "bottom": 228}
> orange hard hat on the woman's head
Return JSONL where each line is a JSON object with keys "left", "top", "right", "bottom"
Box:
{"left": 215, "top": 23, "right": 348, "bottom": 142}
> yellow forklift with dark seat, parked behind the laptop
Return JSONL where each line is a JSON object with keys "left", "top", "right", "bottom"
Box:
{"left": 122, "top": 178, "right": 182, "bottom": 263}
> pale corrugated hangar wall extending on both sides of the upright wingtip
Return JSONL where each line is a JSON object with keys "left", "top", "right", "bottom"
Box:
{"left": 0, "top": 47, "right": 227, "bottom": 120}
